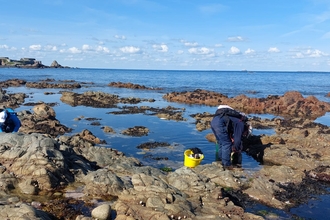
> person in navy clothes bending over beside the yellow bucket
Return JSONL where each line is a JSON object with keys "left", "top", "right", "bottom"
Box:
{"left": 211, "top": 105, "right": 252, "bottom": 170}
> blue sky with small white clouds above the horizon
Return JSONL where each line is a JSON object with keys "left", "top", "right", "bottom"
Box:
{"left": 0, "top": 0, "right": 330, "bottom": 71}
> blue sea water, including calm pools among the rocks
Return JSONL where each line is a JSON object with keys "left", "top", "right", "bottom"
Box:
{"left": 0, "top": 68, "right": 330, "bottom": 219}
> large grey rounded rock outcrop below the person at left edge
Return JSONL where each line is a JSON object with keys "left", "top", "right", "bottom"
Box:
{"left": 0, "top": 133, "right": 73, "bottom": 193}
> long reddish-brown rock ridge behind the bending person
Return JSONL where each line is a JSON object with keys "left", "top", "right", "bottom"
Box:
{"left": 163, "top": 89, "right": 330, "bottom": 119}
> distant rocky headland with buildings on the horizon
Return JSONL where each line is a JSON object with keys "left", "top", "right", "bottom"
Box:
{"left": 0, "top": 57, "right": 71, "bottom": 69}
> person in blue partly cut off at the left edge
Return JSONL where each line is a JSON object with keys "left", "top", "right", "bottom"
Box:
{"left": 0, "top": 108, "right": 21, "bottom": 133}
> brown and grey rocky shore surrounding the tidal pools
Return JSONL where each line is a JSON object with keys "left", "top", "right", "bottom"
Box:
{"left": 0, "top": 79, "right": 330, "bottom": 220}
